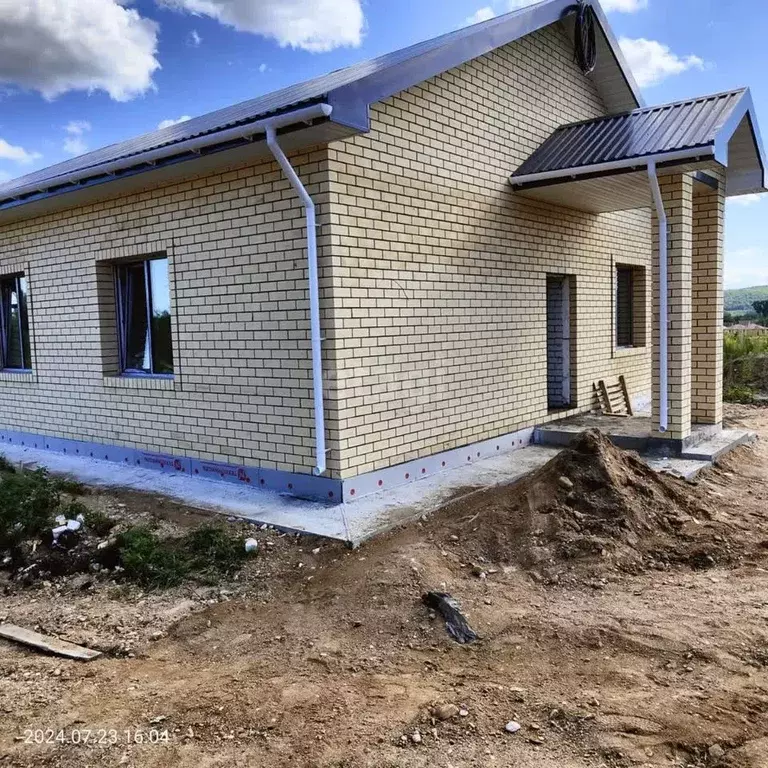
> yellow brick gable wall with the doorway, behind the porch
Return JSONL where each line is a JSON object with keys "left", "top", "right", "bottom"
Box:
{"left": 326, "top": 27, "right": 651, "bottom": 477}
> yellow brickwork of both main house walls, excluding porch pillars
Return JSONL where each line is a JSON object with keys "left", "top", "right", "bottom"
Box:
{"left": 0, "top": 22, "right": 651, "bottom": 478}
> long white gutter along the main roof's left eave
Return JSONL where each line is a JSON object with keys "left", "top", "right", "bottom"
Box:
{"left": 9, "top": 104, "right": 332, "bottom": 199}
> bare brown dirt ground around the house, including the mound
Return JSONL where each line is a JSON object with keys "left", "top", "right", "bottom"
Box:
{"left": 0, "top": 406, "right": 768, "bottom": 768}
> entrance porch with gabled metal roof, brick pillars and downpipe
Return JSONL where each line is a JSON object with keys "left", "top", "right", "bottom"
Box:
{"left": 510, "top": 89, "right": 768, "bottom": 446}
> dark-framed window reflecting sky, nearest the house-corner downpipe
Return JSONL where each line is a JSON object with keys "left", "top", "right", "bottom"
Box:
{"left": 116, "top": 257, "right": 173, "bottom": 376}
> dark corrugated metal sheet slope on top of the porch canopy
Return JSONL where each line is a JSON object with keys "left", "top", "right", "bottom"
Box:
{"left": 512, "top": 88, "right": 748, "bottom": 179}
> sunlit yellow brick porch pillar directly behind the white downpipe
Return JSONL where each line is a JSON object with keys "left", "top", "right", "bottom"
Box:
{"left": 652, "top": 173, "right": 693, "bottom": 440}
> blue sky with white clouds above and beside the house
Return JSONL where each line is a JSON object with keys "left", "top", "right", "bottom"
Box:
{"left": 0, "top": 0, "right": 768, "bottom": 287}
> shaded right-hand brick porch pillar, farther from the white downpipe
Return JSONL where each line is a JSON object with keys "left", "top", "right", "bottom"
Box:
{"left": 691, "top": 170, "right": 725, "bottom": 424}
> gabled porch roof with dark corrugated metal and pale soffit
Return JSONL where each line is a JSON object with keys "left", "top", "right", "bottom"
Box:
{"left": 510, "top": 88, "right": 768, "bottom": 212}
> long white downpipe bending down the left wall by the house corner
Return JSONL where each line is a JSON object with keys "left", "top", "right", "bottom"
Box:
{"left": 267, "top": 125, "right": 325, "bottom": 475}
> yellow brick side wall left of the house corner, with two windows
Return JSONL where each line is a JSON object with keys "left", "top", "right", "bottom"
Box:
{"left": 0, "top": 148, "right": 327, "bottom": 472}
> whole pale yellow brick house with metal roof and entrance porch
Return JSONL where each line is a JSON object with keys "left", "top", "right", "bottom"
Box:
{"left": 0, "top": 0, "right": 766, "bottom": 501}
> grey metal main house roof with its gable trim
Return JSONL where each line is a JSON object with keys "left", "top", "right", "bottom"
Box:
{"left": 0, "top": 0, "right": 643, "bottom": 208}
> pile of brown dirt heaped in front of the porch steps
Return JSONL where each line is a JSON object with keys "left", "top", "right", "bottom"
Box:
{"left": 438, "top": 430, "right": 730, "bottom": 571}
